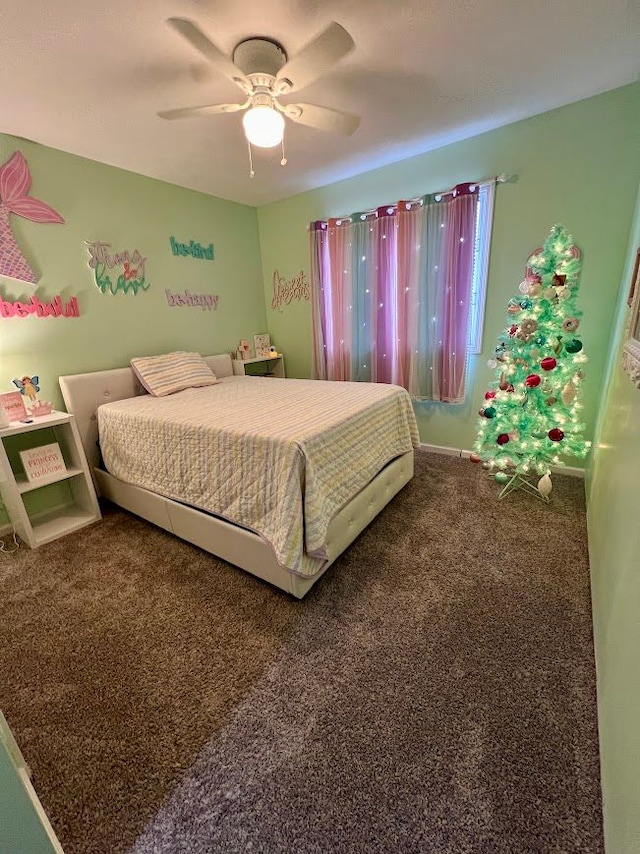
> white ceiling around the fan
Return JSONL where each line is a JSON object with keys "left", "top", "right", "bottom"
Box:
{"left": 0, "top": 0, "right": 640, "bottom": 205}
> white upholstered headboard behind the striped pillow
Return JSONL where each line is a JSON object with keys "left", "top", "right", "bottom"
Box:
{"left": 59, "top": 353, "right": 233, "bottom": 474}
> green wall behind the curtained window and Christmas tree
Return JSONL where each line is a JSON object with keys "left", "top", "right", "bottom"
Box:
{"left": 258, "top": 84, "right": 640, "bottom": 458}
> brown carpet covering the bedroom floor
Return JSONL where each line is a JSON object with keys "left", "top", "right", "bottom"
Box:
{"left": 0, "top": 451, "right": 603, "bottom": 854}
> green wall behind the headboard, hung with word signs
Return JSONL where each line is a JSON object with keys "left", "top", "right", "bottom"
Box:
{"left": 0, "top": 135, "right": 266, "bottom": 527}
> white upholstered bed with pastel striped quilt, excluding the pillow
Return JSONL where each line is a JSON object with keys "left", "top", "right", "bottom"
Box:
{"left": 60, "top": 354, "right": 419, "bottom": 599}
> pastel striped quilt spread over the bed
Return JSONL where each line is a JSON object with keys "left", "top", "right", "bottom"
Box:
{"left": 98, "top": 377, "right": 419, "bottom": 575}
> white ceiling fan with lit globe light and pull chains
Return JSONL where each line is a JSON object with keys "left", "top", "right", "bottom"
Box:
{"left": 158, "top": 18, "right": 360, "bottom": 160}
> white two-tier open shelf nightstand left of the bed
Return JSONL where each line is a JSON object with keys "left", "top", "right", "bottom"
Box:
{"left": 0, "top": 412, "right": 100, "bottom": 549}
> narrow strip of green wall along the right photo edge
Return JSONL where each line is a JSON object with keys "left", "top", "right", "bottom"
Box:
{"left": 587, "top": 182, "right": 640, "bottom": 854}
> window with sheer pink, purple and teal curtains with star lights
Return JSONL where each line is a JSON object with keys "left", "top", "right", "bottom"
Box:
{"left": 309, "top": 181, "right": 495, "bottom": 403}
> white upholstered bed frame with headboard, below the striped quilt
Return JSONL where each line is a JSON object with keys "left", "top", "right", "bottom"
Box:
{"left": 60, "top": 354, "right": 413, "bottom": 599}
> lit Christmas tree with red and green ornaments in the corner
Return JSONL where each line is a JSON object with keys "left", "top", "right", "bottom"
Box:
{"left": 471, "top": 225, "right": 590, "bottom": 500}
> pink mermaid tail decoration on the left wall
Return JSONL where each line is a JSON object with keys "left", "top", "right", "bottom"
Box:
{"left": 0, "top": 151, "right": 64, "bottom": 285}
